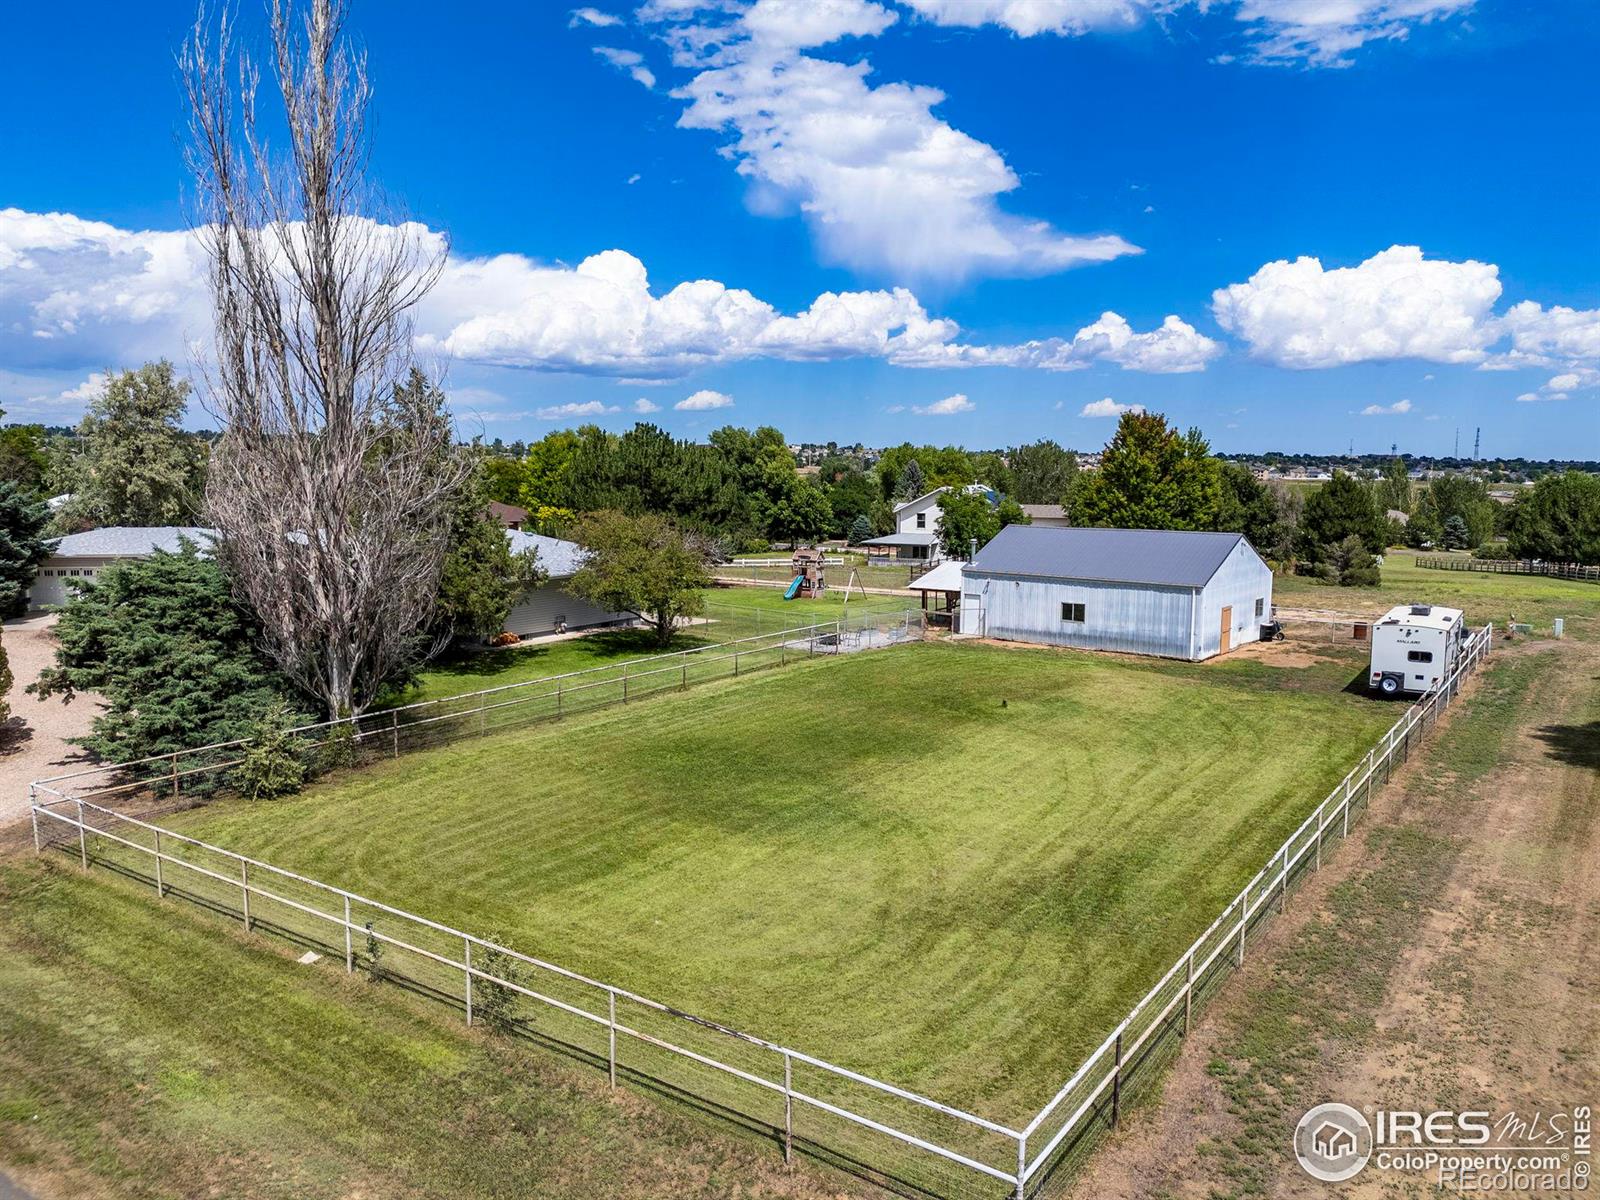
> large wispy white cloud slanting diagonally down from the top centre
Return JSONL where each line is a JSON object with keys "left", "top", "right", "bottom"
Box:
{"left": 646, "top": 0, "right": 1139, "bottom": 280}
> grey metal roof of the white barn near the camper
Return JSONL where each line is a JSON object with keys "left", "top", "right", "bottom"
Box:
{"left": 966, "top": 525, "right": 1245, "bottom": 587}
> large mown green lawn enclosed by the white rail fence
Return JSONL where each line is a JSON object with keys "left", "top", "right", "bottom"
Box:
{"left": 156, "top": 643, "right": 1398, "bottom": 1122}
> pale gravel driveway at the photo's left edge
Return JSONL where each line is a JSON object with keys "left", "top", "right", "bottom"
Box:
{"left": 0, "top": 614, "right": 98, "bottom": 826}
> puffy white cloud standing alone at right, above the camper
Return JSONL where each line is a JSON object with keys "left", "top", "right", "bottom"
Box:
{"left": 1211, "top": 246, "right": 1501, "bottom": 368}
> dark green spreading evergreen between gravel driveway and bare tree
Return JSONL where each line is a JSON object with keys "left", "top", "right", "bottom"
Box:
{"left": 29, "top": 544, "right": 304, "bottom": 762}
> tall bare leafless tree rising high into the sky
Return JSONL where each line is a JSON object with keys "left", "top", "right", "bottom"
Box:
{"left": 179, "top": 0, "right": 467, "bottom": 715}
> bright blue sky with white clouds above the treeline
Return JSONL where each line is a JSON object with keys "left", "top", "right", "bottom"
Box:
{"left": 0, "top": 0, "right": 1600, "bottom": 458}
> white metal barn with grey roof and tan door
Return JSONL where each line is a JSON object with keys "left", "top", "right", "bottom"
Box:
{"left": 962, "top": 525, "right": 1272, "bottom": 661}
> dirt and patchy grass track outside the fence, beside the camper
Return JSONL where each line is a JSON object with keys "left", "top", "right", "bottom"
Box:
{"left": 1074, "top": 642, "right": 1600, "bottom": 1200}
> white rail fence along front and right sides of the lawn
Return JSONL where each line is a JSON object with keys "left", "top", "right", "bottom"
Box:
{"left": 32, "top": 626, "right": 1493, "bottom": 1200}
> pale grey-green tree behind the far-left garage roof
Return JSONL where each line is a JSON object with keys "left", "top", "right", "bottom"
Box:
{"left": 59, "top": 358, "right": 205, "bottom": 526}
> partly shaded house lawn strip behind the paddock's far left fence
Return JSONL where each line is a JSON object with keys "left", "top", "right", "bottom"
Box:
{"left": 379, "top": 587, "right": 917, "bottom": 707}
